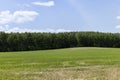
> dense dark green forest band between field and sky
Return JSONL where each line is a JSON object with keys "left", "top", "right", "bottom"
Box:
{"left": 0, "top": 32, "right": 120, "bottom": 52}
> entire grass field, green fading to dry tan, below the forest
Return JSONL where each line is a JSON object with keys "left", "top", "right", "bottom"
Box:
{"left": 0, "top": 48, "right": 120, "bottom": 80}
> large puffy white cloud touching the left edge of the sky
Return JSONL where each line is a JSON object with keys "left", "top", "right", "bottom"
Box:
{"left": 0, "top": 10, "right": 38, "bottom": 24}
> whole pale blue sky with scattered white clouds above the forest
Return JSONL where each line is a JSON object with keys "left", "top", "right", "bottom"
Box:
{"left": 0, "top": 0, "right": 120, "bottom": 33}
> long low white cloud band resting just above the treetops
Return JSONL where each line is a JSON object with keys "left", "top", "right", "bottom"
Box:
{"left": 0, "top": 25, "right": 72, "bottom": 33}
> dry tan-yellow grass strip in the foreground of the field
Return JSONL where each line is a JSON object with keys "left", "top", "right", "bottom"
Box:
{"left": 2, "top": 66, "right": 120, "bottom": 80}
